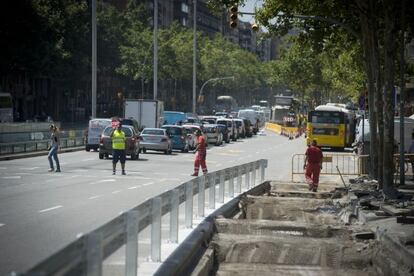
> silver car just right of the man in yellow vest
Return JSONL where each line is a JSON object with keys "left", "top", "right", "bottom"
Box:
{"left": 140, "top": 128, "right": 172, "bottom": 154}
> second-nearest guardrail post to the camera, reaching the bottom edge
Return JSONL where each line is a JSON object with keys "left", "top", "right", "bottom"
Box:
{"left": 125, "top": 210, "right": 139, "bottom": 276}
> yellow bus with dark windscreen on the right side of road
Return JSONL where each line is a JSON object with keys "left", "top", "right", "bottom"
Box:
{"left": 306, "top": 104, "right": 355, "bottom": 151}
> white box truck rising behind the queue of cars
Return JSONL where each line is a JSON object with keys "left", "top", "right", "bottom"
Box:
{"left": 124, "top": 99, "right": 164, "bottom": 129}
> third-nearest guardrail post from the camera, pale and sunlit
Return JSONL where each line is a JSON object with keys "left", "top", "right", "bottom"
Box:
{"left": 151, "top": 197, "right": 162, "bottom": 262}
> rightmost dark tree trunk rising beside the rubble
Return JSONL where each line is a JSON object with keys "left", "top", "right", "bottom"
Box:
{"left": 383, "top": 0, "right": 397, "bottom": 198}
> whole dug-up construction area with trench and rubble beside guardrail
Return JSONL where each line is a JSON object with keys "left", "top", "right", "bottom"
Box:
{"left": 157, "top": 178, "right": 414, "bottom": 276}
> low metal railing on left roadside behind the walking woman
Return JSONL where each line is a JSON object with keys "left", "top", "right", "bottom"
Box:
{"left": 0, "top": 137, "right": 85, "bottom": 155}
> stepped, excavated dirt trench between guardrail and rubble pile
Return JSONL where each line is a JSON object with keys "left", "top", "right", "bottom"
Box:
{"left": 192, "top": 182, "right": 397, "bottom": 276}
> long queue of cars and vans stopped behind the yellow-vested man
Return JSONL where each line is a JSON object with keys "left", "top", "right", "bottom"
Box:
{"left": 85, "top": 110, "right": 264, "bottom": 160}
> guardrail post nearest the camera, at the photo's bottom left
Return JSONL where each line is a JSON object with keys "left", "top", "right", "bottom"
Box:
{"left": 86, "top": 232, "right": 103, "bottom": 276}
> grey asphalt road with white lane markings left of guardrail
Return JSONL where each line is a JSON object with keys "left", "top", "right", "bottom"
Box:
{"left": 0, "top": 131, "right": 306, "bottom": 275}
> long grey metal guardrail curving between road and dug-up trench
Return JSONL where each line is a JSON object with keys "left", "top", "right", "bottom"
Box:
{"left": 22, "top": 159, "right": 267, "bottom": 275}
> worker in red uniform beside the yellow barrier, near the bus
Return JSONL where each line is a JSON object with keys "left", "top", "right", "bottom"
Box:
{"left": 303, "top": 140, "right": 323, "bottom": 192}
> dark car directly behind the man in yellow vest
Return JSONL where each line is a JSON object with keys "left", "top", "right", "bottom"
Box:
{"left": 99, "top": 125, "right": 140, "bottom": 160}
